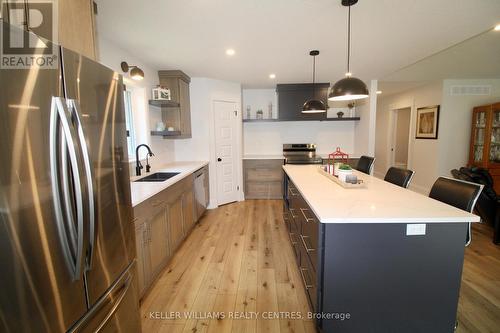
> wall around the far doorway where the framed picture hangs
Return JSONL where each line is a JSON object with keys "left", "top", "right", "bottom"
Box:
{"left": 375, "top": 81, "right": 442, "bottom": 194}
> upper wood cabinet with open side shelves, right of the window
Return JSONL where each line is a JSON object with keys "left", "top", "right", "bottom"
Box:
{"left": 151, "top": 70, "right": 191, "bottom": 139}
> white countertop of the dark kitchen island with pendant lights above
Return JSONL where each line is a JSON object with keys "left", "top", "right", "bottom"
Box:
{"left": 283, "top": 165, "right": 479, "bottom": 223}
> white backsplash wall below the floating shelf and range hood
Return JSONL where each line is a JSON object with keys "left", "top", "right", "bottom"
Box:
{"left": 243, "top": 121, "right": 354, "bottom": 155}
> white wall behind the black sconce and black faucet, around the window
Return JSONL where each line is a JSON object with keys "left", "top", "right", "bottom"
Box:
{"left": 98, "top": 35, "right": 175, "bottom": 167}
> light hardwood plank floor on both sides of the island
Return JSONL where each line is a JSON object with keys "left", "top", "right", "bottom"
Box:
{"left": 141, "top": 200, "right": 500, "bottom": 333}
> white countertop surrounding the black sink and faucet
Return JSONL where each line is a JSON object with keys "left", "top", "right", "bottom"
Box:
{"left": 130, "top": 161, "right": 208, "bottom": 207}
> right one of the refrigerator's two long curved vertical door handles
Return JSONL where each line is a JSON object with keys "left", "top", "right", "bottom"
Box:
{"left": 67, "top": 99, "right": 97, "bottom": 268}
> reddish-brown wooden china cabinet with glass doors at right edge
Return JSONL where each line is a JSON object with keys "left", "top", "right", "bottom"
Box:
{"left": 469, "top": 103, "right": 500, "bottom": 194}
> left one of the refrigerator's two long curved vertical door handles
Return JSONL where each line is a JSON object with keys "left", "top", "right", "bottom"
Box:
{"left": 49, "top": 97, "right": 83, "bottom": 281}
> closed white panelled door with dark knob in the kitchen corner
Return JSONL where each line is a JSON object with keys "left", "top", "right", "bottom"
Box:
{"left": 214, "top": 101, "right": 238, "bottom": 205}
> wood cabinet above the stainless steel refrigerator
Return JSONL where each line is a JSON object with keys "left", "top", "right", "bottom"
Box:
{"left": 6, "top": 0, "right": 96, "bottom": 60}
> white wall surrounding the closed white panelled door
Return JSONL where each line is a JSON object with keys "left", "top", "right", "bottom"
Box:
{"left": 175, "top": 78, "right": 243, "bottom": 208}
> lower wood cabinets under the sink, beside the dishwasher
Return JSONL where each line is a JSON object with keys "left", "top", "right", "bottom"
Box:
{"left": 134, "top": 175, "right": 200, "bottom": 298}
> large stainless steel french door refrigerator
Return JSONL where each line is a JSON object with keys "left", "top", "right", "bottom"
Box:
{"left": 0, "top": 20, "right": 141, "bottom": 333}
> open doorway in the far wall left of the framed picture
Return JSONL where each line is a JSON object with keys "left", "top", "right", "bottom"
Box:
{"left": 391, "top": 107, "right": 411, "bottom": 169}
